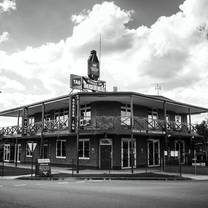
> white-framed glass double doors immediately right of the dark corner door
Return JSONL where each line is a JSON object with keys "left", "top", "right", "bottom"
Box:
{"left": 121, "top": 139, "right": 136, "bottom": 168}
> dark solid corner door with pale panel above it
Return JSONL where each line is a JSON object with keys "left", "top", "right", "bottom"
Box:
{"left": 100, "top": 139, "right": 112, "bottom": 170}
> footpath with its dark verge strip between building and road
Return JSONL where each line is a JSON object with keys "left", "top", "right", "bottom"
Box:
{"left": 0, "top": 163, "right": 208, "bottom": 181}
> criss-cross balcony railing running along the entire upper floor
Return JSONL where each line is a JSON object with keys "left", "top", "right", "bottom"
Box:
{"left": 0, "top": 116, "right": 196, "bottom": 136}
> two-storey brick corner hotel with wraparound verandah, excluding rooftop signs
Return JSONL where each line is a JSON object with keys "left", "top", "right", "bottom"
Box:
{"left": 0, "top": 92, "right": 208, "bottom": 169}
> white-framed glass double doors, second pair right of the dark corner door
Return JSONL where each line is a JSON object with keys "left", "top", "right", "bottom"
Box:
{"left": 148, "top": 139, "right": 160, "bottom": 166}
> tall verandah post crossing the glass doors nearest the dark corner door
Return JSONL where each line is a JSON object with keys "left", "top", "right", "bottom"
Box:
{"left": 130, "top": 95, "right": 134, "bottom": 174}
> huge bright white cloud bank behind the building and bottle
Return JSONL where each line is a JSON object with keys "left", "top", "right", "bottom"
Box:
{"left": 0, "top": 0, "right": 208, "bottom": 125}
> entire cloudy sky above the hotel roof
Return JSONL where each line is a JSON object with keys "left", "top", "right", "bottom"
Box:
{"left": 0, "top": 0, "right": 208, "bottom": 125}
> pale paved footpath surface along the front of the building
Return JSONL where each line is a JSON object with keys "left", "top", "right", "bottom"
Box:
{"left": 0, "top": 163, "right": 208, "bottom": 180}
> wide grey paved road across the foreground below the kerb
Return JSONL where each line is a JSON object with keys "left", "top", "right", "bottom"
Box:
{"left": 0, "top": 180, "right": 208, "bottom": 208}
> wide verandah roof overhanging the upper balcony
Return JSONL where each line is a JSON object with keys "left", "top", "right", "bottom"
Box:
{"left": 0, "top": 92, "right": 208, "bottom": 117}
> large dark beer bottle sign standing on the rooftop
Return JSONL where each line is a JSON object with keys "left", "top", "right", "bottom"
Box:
{"left": 88, "top": 50, "right": 100, "bottom": 81}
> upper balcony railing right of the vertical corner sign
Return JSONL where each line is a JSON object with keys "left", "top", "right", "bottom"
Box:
{"left": 80, "top": 116, "right": 196, "bottom": 134}
